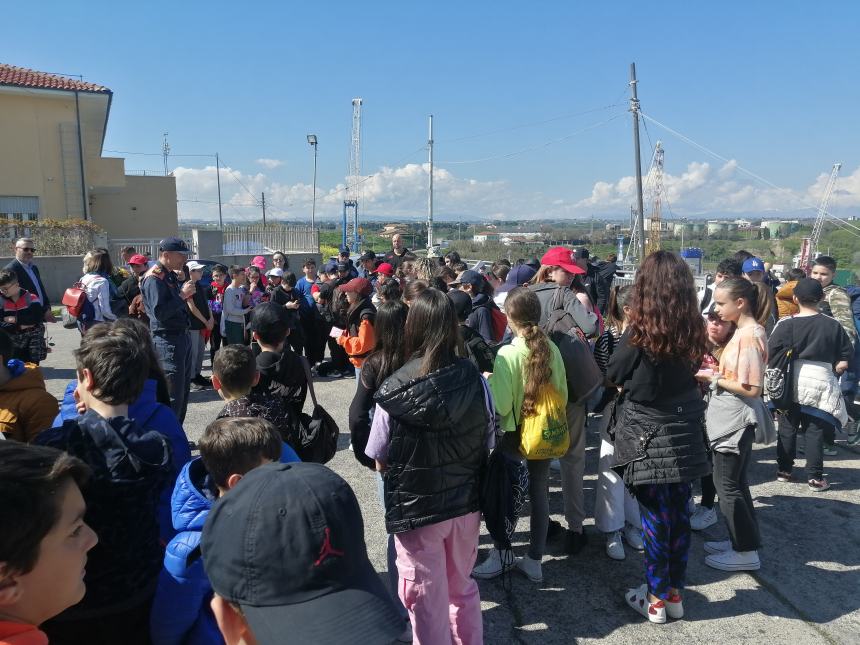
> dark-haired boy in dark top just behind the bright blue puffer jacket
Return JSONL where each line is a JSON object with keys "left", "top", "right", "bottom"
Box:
{"left": 212, "top": 345, "right": 298, "bottom": 461}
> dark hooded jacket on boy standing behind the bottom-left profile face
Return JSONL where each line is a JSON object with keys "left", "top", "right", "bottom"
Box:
{"left": 36, "top": 410, "right": 172, "bottom": 622}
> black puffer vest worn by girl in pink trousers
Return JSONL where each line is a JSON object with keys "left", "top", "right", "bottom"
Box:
{"left": 375, "top": 359, "right": 489, "bottom": 533}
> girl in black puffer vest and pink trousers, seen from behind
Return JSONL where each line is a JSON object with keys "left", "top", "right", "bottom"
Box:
{"left": 365, "top": 289, "right": 495, "bottom": 643}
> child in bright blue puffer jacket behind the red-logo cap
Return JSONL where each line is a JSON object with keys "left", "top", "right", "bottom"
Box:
{"left": 150, "top": 417, "right": 288, "bottom": 645}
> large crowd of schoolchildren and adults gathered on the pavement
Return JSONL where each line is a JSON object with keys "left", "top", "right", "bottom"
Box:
{"left": 0, "top": 235, "right": 860, "bottom": 645}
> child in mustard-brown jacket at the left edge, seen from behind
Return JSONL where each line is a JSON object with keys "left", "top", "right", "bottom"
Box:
{"left": 0, "top": 331, "right": 59, "bottom": 442}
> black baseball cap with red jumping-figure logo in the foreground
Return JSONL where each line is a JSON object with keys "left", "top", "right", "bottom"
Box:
{"left": 200, "top": 463, "right": 405, "bottom": 645}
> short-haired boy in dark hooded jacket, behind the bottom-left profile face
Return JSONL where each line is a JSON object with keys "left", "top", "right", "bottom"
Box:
{"left": 36, "top": 323, "right": 172, "bottom": 645}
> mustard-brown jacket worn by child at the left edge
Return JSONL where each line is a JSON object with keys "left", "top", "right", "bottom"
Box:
{"left": 0, "top": 363, "right": 58, "bottom": 443}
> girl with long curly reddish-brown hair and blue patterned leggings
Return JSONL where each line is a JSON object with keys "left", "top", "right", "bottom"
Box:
{"left": 606, "top": 251, "right": 711, "bottom": 623}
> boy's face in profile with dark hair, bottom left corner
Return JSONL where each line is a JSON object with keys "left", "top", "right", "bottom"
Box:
{"left": 0, "top": 441, "right": 98, "bottom": 645}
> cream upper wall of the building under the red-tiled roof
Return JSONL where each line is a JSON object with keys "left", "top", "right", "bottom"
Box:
{"left": 0, "top": 94, "right": 74, "bottom": 219}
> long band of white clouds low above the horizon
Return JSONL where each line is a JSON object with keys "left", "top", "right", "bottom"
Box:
{"left": 174, "top": 160, "right": 860, "bottom": 221}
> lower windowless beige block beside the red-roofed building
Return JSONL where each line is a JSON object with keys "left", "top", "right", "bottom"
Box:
{"left": 90, "top": 175, "right": 178, "bottom": 239}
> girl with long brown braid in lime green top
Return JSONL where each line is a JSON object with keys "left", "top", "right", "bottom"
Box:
{"left": 472, "top": 287, "right": 567, "bottom": 582}
